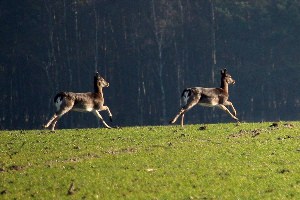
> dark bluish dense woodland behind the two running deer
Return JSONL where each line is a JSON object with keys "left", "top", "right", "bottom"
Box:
{"left": 0, "top": 0, "right": 300, "bottom": 129}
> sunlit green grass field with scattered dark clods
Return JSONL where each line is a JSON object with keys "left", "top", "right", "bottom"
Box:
{"left": 0, "top": 122, "right": 300, "bottom": 199}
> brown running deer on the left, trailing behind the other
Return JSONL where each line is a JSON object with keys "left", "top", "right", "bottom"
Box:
{"left": 44, "top": 72, "right": 112, "bottom": 131}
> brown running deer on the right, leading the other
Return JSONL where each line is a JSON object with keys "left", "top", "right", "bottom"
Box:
{"left": 170, "top": 69, "right": 239, "bottom": 127}
